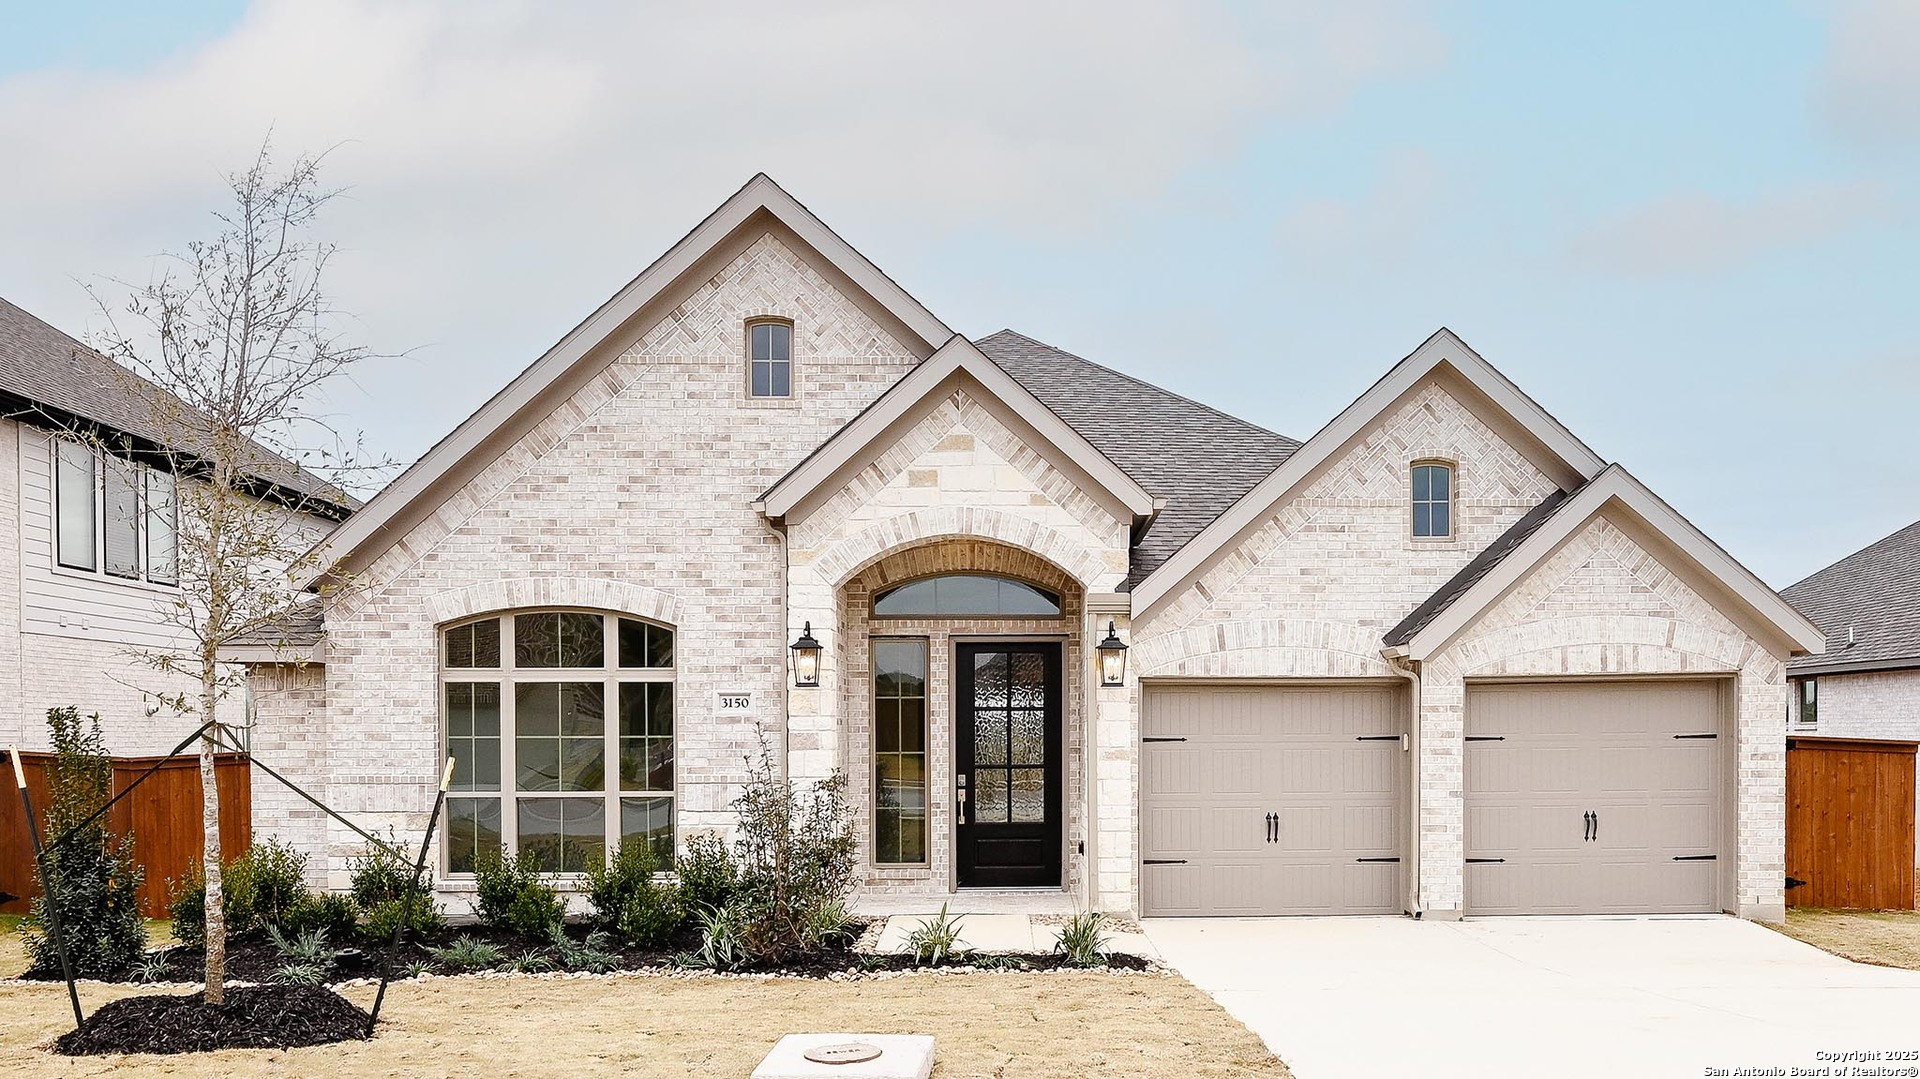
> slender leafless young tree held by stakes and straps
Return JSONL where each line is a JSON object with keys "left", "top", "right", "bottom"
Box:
{"left": 94, "top": 144, "right": 386, "bottom": 1004}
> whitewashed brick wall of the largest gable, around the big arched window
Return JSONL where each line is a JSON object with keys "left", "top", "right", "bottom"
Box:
{"left": 259, "top": 234, "right": 916, "bottom": 887}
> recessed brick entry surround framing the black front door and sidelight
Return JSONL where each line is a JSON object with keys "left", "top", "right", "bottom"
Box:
{"left": 837, "top": 540, "right": 1091, "bottom": 904}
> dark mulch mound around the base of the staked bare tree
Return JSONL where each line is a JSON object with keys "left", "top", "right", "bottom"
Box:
{"left": 54, "top": 985, "right": 367, "bottom": 1056}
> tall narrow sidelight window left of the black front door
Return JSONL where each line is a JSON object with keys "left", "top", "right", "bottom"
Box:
{"left": 874, "top": 639, "right": 927, "bottom": 864}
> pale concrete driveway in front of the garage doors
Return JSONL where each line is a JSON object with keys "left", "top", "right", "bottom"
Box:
{"left": 1144, "top": 918, "right": 1920, "bottom": 1079}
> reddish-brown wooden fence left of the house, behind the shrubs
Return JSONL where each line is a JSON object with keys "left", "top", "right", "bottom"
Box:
{"left": 0, "top": 749, "right": 253, "bottom": 918}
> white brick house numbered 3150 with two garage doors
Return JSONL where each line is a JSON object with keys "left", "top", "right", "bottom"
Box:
{"left": 236, "top": 177, "right": 1822, "bottom": 918}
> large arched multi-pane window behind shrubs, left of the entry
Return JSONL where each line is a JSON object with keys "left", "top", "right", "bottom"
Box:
{"left": 442, "top": 611, "right": 674, "bottom": 874}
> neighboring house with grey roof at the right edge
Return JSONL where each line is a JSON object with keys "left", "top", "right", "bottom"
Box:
{"left": 1780, "top": 522, "right": 1920, "bottom": 868}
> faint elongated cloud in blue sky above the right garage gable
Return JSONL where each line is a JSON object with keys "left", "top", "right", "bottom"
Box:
{"left": 1571, "top": 184, "right": 1884, "bottom": 276}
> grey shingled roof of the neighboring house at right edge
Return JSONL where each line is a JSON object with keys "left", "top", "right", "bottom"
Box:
{"left": 1780, "top": 522, "right": 1920, "bottom": 674}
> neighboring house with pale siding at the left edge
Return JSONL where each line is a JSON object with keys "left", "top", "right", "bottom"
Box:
{"left": 0, "top": 289, "right": 353, "bottom": 755}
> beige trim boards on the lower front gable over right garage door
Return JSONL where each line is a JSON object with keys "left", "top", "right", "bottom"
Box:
{"left": 1388, "top": 465, "right": 1826, "bottom": 662}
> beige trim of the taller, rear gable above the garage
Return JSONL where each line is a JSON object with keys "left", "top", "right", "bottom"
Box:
{"left": 1133, "top": 326, "right": 1607, "bottom": 616}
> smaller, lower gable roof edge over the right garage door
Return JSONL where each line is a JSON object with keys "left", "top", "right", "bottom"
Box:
{"left": 1384, "top": 465, "right": 1826, "bottom": 660}
